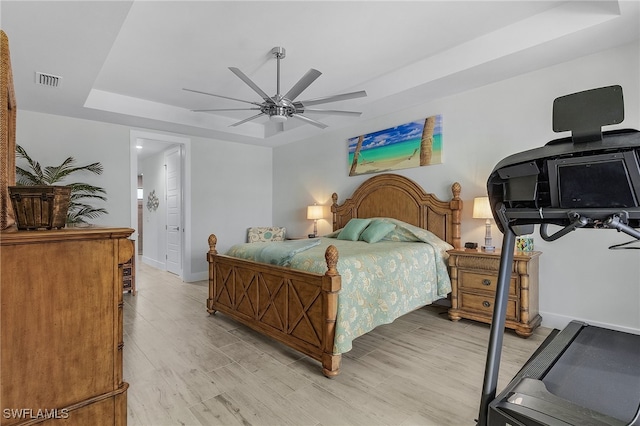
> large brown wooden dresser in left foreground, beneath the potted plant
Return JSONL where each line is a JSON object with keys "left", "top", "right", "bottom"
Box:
{"left": 0, "top": 228, "right": 134, "bottom": 426}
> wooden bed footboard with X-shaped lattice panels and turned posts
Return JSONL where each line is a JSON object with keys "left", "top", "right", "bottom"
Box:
{"left": 207, "top": 234, "right": 341, "bottom": 377}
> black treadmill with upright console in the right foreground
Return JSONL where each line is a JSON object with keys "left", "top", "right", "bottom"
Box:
{"left": 477, "top": 86, "right": 640, "bottom": 426}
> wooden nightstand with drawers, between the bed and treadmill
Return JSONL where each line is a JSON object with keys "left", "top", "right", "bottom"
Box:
{"left": 448, "top": 250, "right": 542, "bottom": 337}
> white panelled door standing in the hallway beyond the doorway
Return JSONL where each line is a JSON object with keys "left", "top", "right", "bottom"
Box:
{"left": 165, "top": 147, "right": 184, "bottom": 276}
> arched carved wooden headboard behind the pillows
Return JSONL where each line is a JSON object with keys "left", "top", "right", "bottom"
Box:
{"left": 331, "top": 174, "right": 462, "bottom": 248}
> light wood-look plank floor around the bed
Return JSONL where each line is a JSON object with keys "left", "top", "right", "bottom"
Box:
{"left": 124, "top": 262, "right": 550, "bottom": 426}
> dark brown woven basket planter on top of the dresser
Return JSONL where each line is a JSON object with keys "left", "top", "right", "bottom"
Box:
{"left": 9, "top": 186, "right": 71, "bottom": 230}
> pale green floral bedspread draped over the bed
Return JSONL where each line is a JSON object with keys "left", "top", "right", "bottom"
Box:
{"left": 228, "top": 219, "right": 453, "bottom": 354}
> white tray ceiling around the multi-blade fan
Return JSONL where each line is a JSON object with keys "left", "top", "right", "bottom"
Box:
{"left": 0, "top": 0, "right": 640, "bottom": 146}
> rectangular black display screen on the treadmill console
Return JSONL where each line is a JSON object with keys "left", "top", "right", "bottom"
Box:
{"left": 557, "top": 157, "right": 638, "bottom": 209}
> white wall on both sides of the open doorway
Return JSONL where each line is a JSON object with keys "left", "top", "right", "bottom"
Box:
{"left": 16, "top": 109, "right": 272, "bottom": 281}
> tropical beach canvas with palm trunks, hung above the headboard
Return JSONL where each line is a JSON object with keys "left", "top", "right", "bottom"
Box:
{"left": 348, "top": 115, "right": 442, "bottom": 176}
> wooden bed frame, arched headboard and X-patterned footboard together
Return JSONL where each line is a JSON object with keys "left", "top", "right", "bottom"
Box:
{"left": 207, "top": 174, "right": 462, "bottom": 377}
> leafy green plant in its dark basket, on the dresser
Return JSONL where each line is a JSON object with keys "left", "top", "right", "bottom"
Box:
{"left": 12, "top": 145, "right": 108, "bottom": 228}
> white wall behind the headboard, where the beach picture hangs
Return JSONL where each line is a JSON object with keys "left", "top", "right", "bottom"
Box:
{"left": 273, "top": 42, "right": 640, "bottom": 332}
